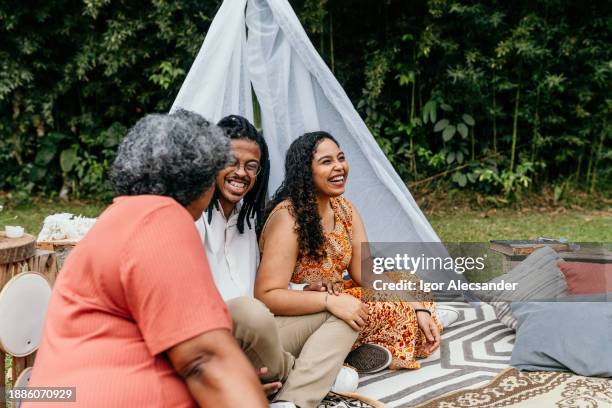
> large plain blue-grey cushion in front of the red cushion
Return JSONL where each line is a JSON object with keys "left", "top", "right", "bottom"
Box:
{"left": 510, "top": 295, "right": 612, "bottom": 377}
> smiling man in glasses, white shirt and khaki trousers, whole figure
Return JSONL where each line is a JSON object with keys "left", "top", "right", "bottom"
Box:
{"left": 196, "top": 115, "right": 357, "bottom": 408}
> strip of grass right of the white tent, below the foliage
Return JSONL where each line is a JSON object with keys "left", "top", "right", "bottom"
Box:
{"left": 412, "top": 185, "right": 612, "bottom": 242}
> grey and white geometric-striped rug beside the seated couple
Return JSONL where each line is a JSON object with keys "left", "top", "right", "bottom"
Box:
{"left": 357, "top": 302, "right": 514, "bottom": 407}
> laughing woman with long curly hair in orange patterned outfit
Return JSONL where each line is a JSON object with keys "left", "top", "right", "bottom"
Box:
{"left": 255, "top": 132, "right": 440, "bottom": 373}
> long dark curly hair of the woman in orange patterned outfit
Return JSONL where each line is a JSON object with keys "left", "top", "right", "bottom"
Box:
{"left": 260, "top": 131, "right": 340, "bottom": 259}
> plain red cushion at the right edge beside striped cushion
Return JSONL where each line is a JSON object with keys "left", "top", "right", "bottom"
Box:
{"left": 559, "top": 262, "right": 612, "bottom": 295}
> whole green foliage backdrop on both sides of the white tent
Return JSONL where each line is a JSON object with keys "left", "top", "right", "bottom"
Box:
{"left": 0, "top": 0, "right": 612, "bottom": 205}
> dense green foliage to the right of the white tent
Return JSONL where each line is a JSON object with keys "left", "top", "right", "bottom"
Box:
{"left": 331, "top": 0, "right": 612, "bottom": 199}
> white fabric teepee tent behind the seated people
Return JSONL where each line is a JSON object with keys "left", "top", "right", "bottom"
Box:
{"left": 172, "top": 0, "right": 440, "bottom": 243}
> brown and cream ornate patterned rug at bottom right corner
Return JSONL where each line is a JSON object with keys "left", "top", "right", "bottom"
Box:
{"left": 418, "top": 368, "right": 612, "bottom": 408}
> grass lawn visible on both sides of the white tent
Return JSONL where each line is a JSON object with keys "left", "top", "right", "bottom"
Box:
{"left": 0, "top": 197, "right": 612, "bottom": 242}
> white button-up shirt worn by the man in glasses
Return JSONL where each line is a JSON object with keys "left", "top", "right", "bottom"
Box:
{"left": 196, "top": 204, "right": 259, "bottom": 301}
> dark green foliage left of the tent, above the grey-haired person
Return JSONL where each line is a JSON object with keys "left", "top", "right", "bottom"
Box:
{"left": 0, "top": 0, "right": 220, "bottom": 199}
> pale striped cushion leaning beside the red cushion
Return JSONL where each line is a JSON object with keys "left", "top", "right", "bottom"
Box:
{"left": 480, "top": 246, "right": 567, "bottom": 329}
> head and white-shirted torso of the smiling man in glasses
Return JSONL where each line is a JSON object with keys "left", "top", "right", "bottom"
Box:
{"left": 196, "top": 115, "right": 270, "bottom": 302}
